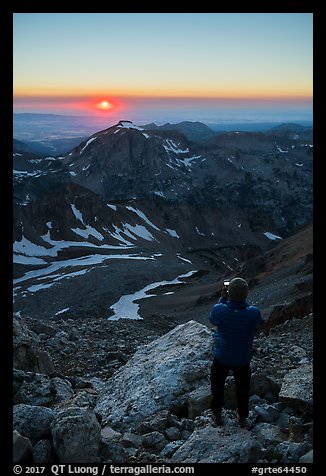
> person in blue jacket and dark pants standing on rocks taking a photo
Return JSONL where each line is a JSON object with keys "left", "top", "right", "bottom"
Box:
{"left": 209, "top": 277, "right": 263, "bottom": 427}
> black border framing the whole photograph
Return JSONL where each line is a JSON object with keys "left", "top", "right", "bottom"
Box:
{"left": 5, "top": 0, "right": 320, "bottom": 475}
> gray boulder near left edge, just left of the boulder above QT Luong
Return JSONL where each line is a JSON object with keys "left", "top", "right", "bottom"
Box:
{"left": 13, "top": 403, "right": 56, "bottom": 440}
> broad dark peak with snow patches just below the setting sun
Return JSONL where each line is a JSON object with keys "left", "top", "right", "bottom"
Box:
{"left": 59, "top": 120, "right": 196, "bottom": 200}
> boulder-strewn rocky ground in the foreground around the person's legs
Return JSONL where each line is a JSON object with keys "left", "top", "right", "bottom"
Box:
{"left": 13, "top": 314, "right": 313, "bottom": 464}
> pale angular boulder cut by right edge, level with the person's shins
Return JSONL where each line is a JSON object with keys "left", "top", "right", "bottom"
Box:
{"left": 279, "top": 364, "right": 313, "bottom": 413}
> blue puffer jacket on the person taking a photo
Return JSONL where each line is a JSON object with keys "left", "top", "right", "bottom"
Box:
{"left": 209, "top": 297, "right": 263, "bottom": 367}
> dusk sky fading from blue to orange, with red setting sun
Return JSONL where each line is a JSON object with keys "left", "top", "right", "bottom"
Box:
{"left": 13, "top": 13, "right": 313, "bottom": 123}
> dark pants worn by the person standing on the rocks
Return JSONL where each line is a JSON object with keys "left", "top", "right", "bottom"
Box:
{"left": 211, "top": 357, "right": 251, "bottom": 417}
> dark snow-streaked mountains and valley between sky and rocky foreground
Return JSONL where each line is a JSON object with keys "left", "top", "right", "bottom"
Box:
{"left": 13, "top": 121, "right": 313, "bottom": 322}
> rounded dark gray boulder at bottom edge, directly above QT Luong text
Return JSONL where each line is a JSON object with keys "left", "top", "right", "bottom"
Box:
{"left": 51, "top": 407, "right": 101, "bottom": 463}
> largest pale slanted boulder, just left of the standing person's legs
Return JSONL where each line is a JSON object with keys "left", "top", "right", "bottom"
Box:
{"left": 95, "top": 321, "right": 211, "bottom": 429}
